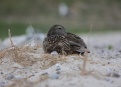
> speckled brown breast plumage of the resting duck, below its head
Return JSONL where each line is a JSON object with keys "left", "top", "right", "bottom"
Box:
{"left": 43, "top": 35, "right": 70, "bottom": 54}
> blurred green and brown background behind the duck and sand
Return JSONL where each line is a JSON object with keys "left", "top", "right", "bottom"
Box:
{"left": 0, "top": 0, "right": 121, "bottom": 38}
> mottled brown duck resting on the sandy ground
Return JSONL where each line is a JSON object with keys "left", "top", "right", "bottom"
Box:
{"left": 43, "top": 25, "right": 90, "bottom": 55}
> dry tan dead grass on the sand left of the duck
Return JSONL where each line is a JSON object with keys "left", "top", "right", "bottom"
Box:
{"left": 0, "top": 30, "right": 65, "bottom": 66}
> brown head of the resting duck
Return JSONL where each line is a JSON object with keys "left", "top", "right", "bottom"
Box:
{"left": 47, "top": 25, "right": 66, "bottom": 37}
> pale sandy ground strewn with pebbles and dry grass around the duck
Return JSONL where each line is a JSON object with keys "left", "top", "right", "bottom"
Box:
{"left": 0, "top": 32, "right": 121, "bottom": 87}
